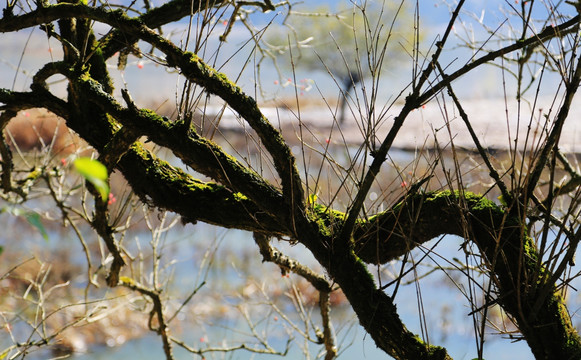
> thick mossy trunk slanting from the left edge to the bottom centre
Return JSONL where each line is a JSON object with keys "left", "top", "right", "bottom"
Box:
{"left": 0, "top": 51, "right": 449, "bottom": 359}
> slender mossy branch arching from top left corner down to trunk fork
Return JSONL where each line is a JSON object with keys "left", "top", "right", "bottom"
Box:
{"left": 0, "top": 3, "right": 305, "bottom": 223}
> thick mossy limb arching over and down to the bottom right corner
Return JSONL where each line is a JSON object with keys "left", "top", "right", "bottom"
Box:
{"left": 318, "top": 191, "right": 581, "bottom": 359}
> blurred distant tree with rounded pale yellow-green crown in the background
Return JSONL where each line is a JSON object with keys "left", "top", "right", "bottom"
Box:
{"left": 263, "top": 1, "right": 417, "bottom": 124}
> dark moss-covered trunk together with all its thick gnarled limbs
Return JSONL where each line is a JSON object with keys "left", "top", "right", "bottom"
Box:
{"left": 0, "top": 1, "right": 581, "bottom": 359}
